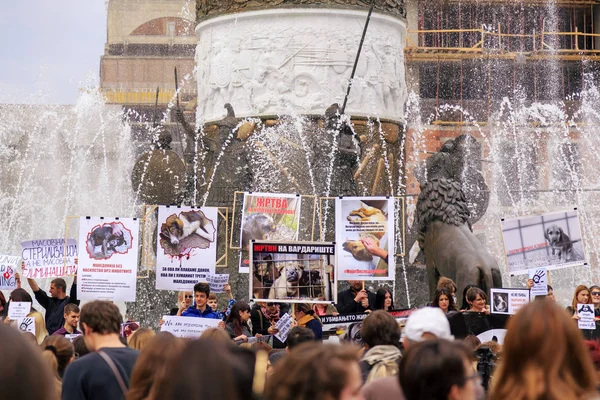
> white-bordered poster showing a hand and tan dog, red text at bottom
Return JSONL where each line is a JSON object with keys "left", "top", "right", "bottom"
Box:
{"left": 335, "top": 197, "right": 396, "bottom": 281}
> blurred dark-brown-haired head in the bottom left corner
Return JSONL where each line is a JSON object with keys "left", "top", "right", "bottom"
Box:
{"left": 0, "top": 324, "right": 58, "bottom": 400}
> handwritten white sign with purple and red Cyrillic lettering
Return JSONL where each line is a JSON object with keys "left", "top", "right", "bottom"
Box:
{"left": 21, "top": 239, "right": 77, "bottom": 279}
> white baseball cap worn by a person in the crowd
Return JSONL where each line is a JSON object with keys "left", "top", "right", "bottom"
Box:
{"left": 402, "top": 307, "right": 454, "bottom": 342}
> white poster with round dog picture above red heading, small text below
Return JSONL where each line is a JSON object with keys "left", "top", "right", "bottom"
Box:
{"left": 77, "top": 217, "right": 139, "bottom": 301}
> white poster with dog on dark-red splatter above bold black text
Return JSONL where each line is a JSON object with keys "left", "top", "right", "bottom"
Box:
{"left": 156, "top": 206, "right": 218, "bottom": 291}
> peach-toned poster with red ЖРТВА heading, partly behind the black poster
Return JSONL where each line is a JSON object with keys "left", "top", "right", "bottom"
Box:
{"left": 239, "top": 193, "right": 302, "bottom": 274}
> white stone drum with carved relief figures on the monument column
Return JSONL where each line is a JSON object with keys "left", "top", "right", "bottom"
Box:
{"left": 196, "top": 10, "right": 407, "bottom": 121}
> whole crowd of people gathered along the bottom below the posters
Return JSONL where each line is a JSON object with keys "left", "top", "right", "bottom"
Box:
{"left": 0, "top": 277, "right": 600, "bottom": 400}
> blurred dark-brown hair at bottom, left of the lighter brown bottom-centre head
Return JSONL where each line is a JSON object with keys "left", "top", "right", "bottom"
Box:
{"left": 152, "top": 339, "right": 255, "bottom": 400}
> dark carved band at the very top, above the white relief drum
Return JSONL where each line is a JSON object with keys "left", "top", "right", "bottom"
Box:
{"left": 196, "top": 0, "right": 406, "bottom": 22}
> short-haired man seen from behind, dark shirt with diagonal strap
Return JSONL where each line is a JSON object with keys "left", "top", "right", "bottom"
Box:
{"left": 62, "top": 300, "right": 139, "bottom": 400}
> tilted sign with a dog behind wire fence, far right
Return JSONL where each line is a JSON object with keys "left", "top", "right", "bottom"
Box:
{"left": 502, "top": 210, "right": 586, "bottom": 275}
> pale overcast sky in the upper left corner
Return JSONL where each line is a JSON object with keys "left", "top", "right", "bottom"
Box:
{"left": 0, "top": 0, "right": 106, "bottom": 104}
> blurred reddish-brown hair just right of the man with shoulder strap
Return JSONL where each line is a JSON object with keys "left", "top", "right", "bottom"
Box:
{"left": 127, "top": 328, "right": 185, "bottom": 400}
